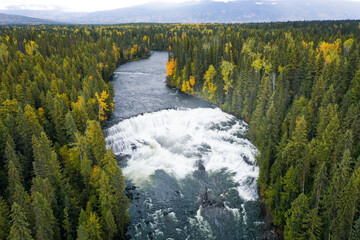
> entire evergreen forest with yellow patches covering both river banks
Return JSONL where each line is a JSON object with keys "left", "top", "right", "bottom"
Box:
{"left": 0, "top": 21, "right": 360, "bottom": 240}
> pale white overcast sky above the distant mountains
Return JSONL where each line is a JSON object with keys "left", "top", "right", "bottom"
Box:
{"left": 0, "top": 0, "right": 360, "bottom": 12}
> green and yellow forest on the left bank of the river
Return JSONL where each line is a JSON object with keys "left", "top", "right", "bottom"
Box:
{"left": 0, "top": 25, "right": 172, "bottom": 240}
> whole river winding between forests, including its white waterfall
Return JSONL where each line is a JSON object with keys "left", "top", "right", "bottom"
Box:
{"left": 105, "top": 52, "right": 266, "bottom": 240}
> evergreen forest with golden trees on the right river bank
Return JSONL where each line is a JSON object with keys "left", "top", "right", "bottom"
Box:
{"left": 167, "top": 21, "right": 360, "bottom": 239}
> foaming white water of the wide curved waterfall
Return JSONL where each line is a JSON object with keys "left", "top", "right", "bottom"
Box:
{"left": 105, "top": 108, "right": 259, "bottom": 200}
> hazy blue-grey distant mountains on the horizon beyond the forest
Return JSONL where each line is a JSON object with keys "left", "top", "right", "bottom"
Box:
{"left": 0, "top": 0, "right": 360, "bottom": 24}
